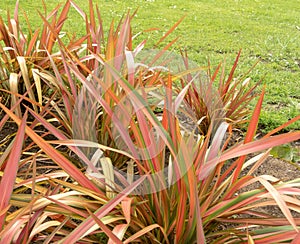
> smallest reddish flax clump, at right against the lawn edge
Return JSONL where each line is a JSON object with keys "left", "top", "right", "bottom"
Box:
{"left": 176, "top": 50, "right": 261, "bottom": 134}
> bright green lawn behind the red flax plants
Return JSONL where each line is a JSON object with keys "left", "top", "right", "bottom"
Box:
{"left": 0, "top": 0, "right": 300, "bottom": 131}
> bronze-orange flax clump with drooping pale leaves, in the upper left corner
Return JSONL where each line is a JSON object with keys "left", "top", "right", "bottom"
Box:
{"left": 0, "top": 1, "right": 86, "bottom": 117}
